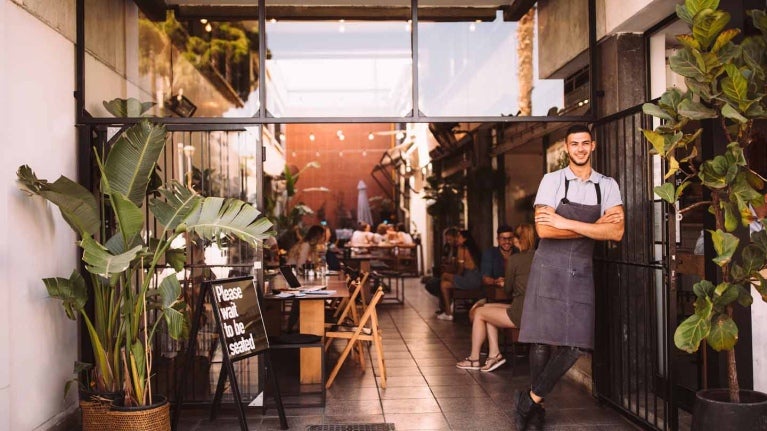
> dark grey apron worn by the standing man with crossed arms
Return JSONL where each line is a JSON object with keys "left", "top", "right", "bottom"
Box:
{"left": 519, "top": 179, "right": 602, "bottom": 349}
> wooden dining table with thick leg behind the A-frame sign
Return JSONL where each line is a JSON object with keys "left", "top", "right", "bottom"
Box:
{"left": 264, "top": 273, "right": 349, "bottom": 384}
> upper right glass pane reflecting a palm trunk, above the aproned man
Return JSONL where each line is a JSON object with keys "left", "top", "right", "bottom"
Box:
{"left": 418, "top": 0, "right": 589, "bottom": 116}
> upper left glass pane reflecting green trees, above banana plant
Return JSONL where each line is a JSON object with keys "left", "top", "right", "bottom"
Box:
{"left": 85, "top": 7, "right": 258, "bottom": 117}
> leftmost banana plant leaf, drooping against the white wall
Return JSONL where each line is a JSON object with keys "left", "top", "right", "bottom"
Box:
{"left": 16, "top": 165, "right": 101, "bottom": 237}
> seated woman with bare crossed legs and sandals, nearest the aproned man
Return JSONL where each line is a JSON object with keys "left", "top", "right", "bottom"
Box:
{"left": 455, "top": 224, "right": 535, "bottom": 372}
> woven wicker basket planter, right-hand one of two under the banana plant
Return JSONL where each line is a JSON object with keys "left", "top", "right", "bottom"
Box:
{"left": 107, "top": 395, "right": 170, "bottom": 431}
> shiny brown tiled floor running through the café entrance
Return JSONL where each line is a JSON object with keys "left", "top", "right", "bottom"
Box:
{"left": 180, "top": 279, "right": 637, "bottom": 431}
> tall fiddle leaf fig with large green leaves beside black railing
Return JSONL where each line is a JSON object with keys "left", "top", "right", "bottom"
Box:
{"left": 643, "top": 0, "right": 767, "bottom": 402}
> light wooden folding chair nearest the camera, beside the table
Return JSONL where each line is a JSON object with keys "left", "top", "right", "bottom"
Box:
{"left": 325, "top": 287, "right": 386, "bottom": 389}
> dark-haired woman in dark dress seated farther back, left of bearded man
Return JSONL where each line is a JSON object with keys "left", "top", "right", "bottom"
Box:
{"left": 437, "top": 230, "right": 482, "bottom": 320}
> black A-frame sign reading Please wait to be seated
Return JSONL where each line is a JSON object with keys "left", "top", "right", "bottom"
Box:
{"left": 173, "top": 276, "right": 288, "bottom": 431}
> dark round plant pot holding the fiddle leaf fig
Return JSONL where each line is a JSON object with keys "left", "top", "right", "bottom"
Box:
{"left": 691, "top": 389, "right": 767, "bottom": 431}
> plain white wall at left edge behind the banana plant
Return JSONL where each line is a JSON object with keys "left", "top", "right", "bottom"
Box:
{"left": 0, "top": 0, "right": 78, "bottom": 430}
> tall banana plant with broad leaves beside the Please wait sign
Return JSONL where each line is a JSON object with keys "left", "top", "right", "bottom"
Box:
{"left": 17, "top": 99, "right": 272, "bottom": 430}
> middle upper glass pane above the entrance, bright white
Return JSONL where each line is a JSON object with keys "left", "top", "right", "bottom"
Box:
{"left": 266, "top": 1, "right": 412, "bottom": 117}
